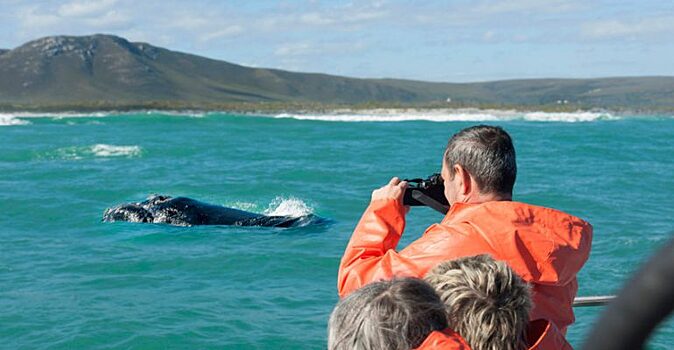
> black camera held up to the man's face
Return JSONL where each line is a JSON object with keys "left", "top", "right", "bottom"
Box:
{"left": 403, "top": 174, "right": 449, "bottom": 214}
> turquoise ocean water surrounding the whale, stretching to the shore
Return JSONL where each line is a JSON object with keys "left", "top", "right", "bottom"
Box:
{"left": 0, "top": 111, "right": 674, "bottom": 349}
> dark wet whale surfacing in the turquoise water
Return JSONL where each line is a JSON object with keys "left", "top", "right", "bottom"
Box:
{"left": 102, "top": 195, "right": 325, "bottom": 228}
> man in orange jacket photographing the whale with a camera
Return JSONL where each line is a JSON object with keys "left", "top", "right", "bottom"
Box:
{"left": 337, "top": 125, "right": 592, "bottom": 342}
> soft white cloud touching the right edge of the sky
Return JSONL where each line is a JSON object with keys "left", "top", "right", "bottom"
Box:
{"left": 581, "top": 16, "right": 674, "bottom": 39}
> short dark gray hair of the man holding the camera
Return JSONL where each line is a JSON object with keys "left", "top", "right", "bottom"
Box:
{"left": 444, "top": 125, "right": 517, "bottom": 195}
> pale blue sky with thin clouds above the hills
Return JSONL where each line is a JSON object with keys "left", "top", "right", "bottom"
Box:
{"left": 0, "top": 0, "right": 674, "bottom": 82}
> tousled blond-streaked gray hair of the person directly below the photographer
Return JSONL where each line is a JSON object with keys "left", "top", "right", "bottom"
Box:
{"left": 424, "top": 255, "right": 531, "bottom": 350}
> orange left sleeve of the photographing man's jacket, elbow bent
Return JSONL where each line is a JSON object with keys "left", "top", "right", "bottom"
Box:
{"left": 337, "top": 200, "right": 418, "bottom": 298}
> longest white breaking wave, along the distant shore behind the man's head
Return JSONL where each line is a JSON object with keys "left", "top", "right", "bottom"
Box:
{"left": 271, "top": 110, "right": 622, "bottom": 123}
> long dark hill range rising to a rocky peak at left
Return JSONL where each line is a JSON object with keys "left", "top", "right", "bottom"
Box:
{"left": 0, "top": 35, "right": 674, "bottom": 109}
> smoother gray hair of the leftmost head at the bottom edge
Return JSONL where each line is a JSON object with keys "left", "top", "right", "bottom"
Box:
{"left": 328, "top": 278, "right": 447, "bottom": 350}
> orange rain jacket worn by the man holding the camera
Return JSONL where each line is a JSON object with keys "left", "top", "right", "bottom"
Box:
{"left": 337, "top": 200, "right": 592, "bottom": 334}
